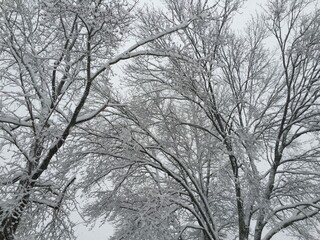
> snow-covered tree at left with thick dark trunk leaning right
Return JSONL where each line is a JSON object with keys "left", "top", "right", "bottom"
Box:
{"left": 0, "top": 0, "right": 197, "bottom": 240}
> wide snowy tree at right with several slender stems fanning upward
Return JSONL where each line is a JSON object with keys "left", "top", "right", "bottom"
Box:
{"left": 78, "top": 0, "right": 320, "bottom": 240}
